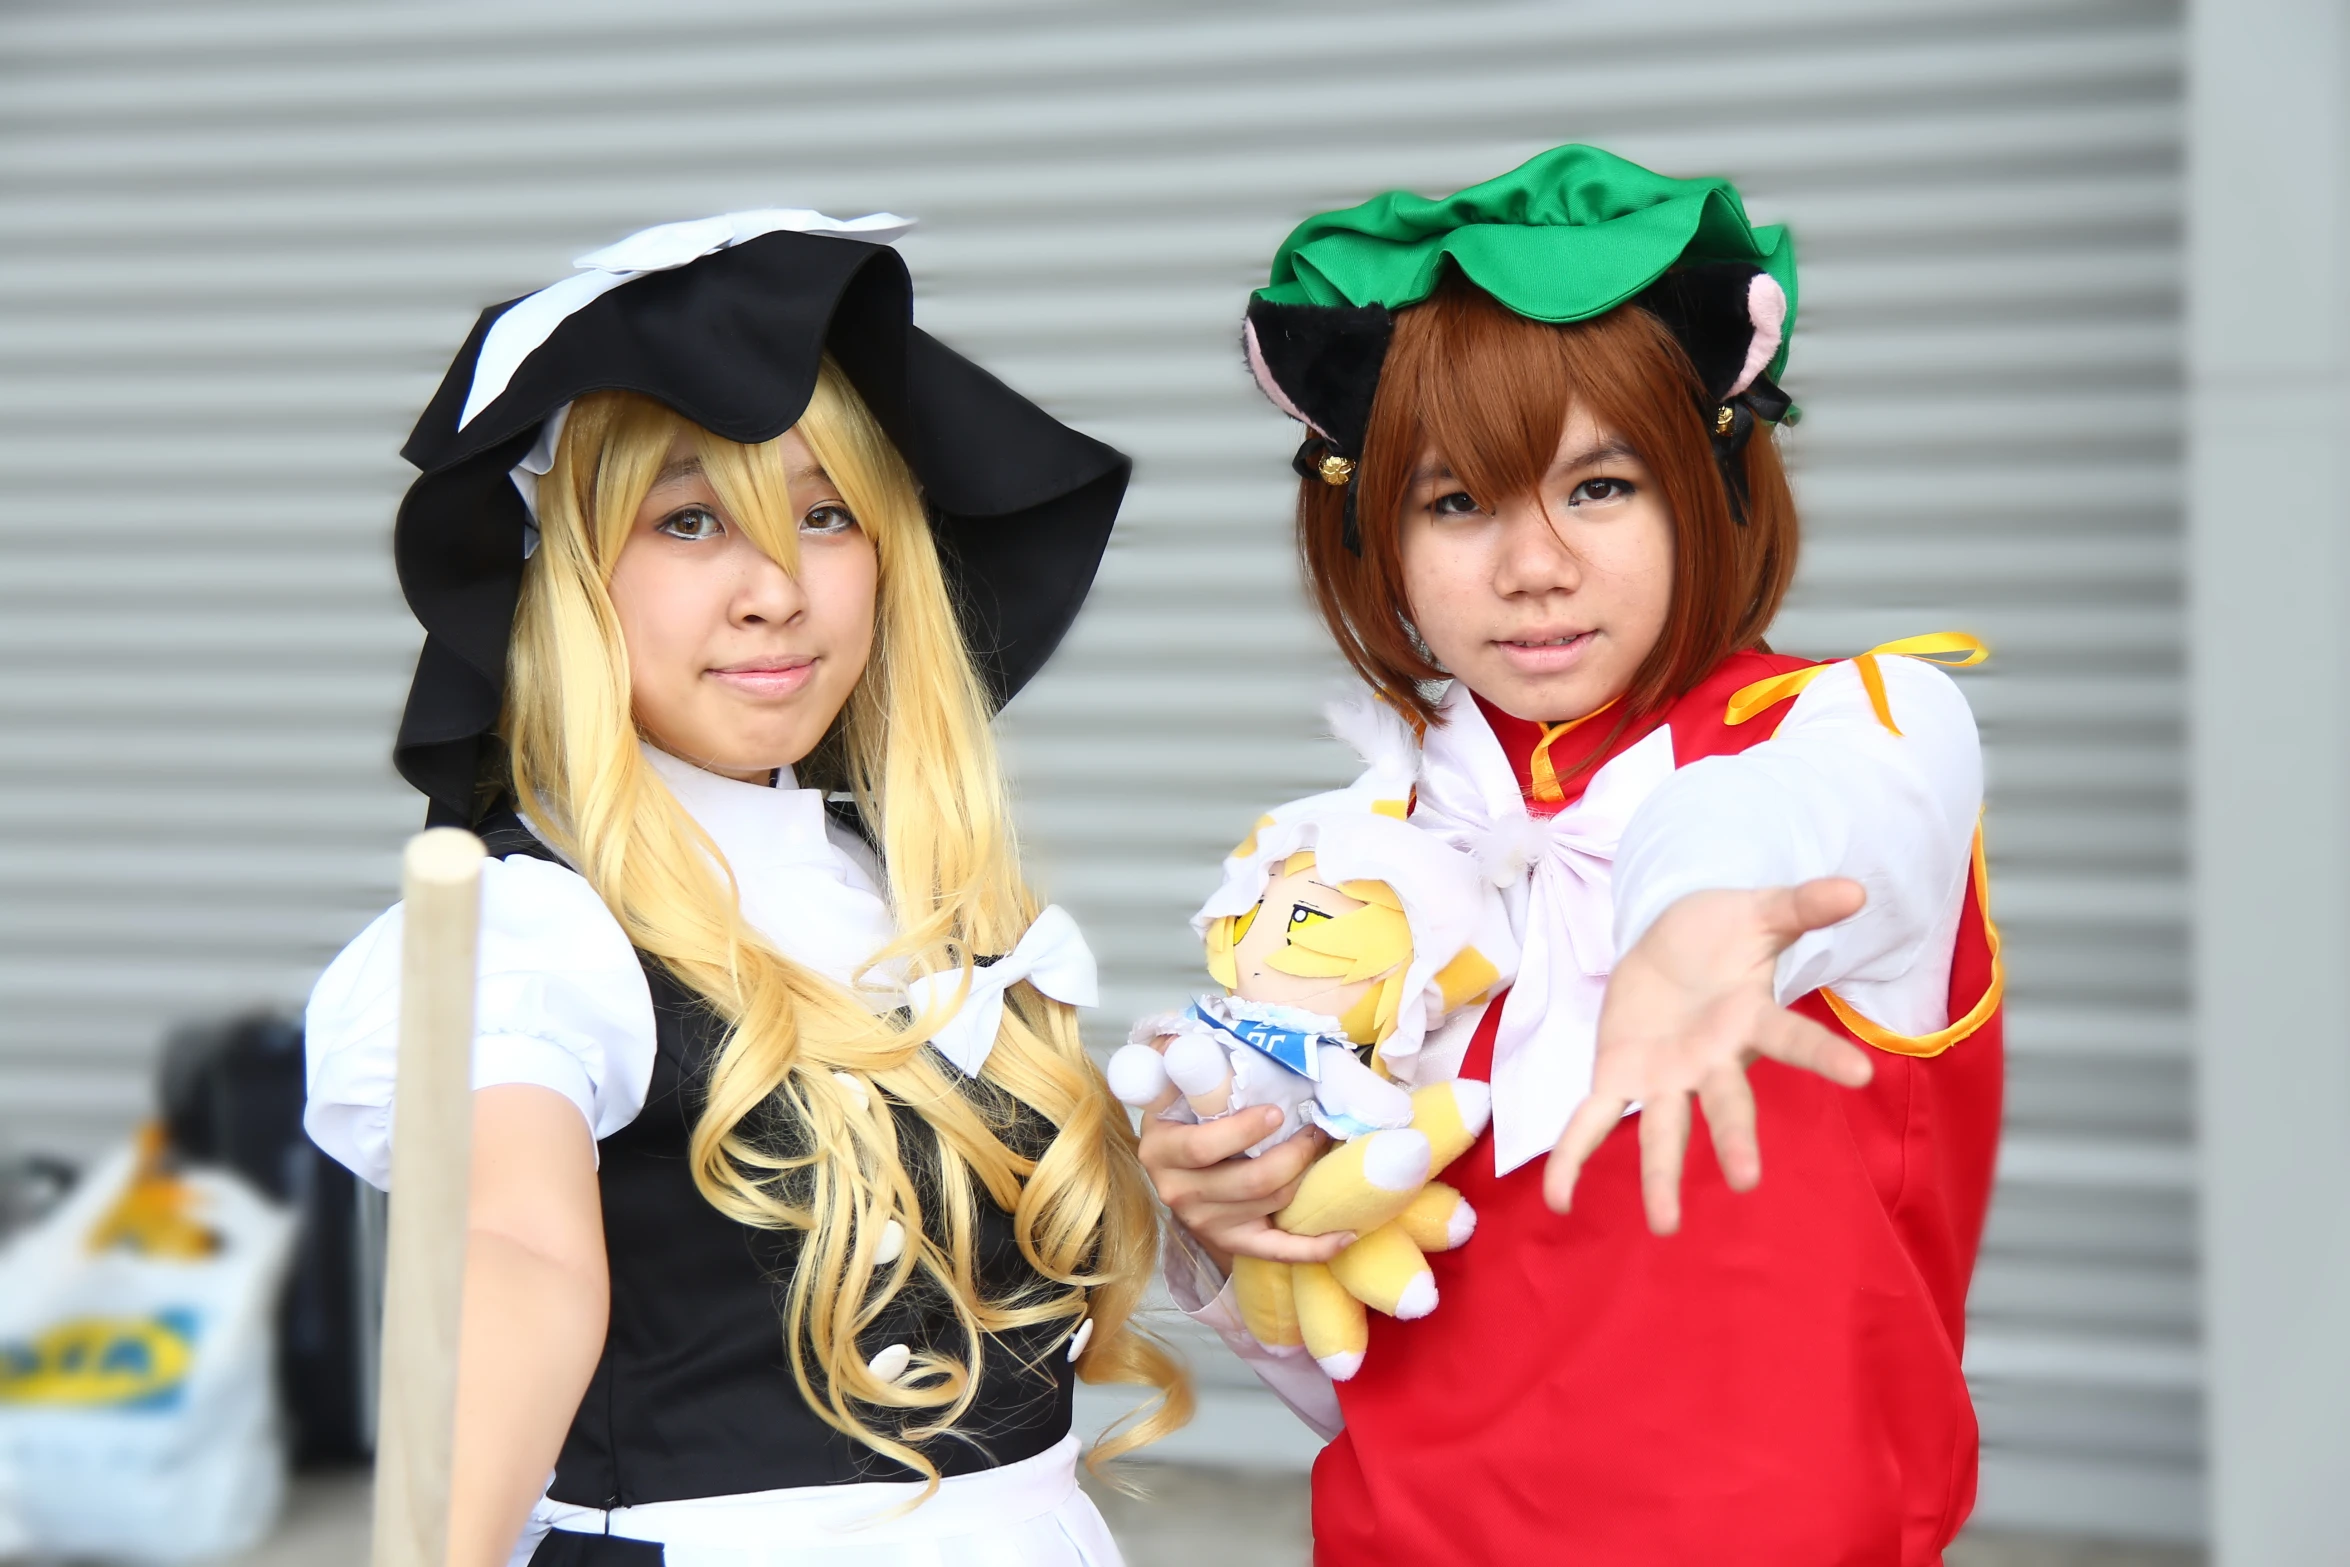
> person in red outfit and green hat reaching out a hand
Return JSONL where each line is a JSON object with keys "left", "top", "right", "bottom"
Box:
{"left": 1142, "top": 146, "right": 2002, "bottom": 1567}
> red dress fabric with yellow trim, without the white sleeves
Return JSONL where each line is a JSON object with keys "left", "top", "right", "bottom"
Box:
{"left": 1314, "top": 653, "right": 2002, "bottom": 1567}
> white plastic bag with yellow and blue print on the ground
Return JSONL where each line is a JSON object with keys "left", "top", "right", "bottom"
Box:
{"left": 0, "top": 1132, "right": 294, "bottom": 1562}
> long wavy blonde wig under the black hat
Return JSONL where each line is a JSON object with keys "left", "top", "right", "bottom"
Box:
{"left": 501, "top": 362, "right": 1191, "bottom": 1487}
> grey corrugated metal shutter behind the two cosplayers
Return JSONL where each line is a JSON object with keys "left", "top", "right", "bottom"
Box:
{"left": 0, "top": 0, "right": 2200, "bottom": 1534}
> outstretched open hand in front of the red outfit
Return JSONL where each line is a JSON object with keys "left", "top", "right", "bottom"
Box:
{"left": 1542, "top": 876, "right": 1871, "bottom": 1236}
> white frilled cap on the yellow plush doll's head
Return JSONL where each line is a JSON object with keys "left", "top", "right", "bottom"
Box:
{"left": 1191, "top": 693, "right": 1518, "bottom": 1081}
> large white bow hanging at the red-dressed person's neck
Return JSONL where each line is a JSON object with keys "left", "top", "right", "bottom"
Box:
{"left": 1412, "top": 686, "right": 1673, "bottom": 1175}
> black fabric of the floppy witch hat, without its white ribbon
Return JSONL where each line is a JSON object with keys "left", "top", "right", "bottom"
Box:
{"left": 392, "top": 233, "right": 1130, "bottom": 822}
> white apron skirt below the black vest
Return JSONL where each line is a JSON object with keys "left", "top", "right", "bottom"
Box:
{"left": 512, "top": 1435, "right": 1123, "bottom": 1567}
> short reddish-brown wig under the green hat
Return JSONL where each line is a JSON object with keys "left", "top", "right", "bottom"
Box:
{"left": 1297, "top": 275, "right": 1795, "bottom": 728}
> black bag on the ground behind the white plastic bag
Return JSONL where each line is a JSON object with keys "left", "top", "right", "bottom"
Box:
{"left": 160, "top": 1013, "right": 376, "bottom": 1464}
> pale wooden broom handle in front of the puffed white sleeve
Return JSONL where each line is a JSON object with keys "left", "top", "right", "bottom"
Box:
{"left": 374, "top": 827, "right": 486, "bottom": 1567}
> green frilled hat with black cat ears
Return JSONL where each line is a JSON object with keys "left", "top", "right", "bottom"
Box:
{"left": 1243, "top": 146, "right": 1795, "bottom": 540}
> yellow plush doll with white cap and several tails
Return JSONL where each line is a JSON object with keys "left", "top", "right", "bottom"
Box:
{"left": 1109, "top": 698, "right": 1516, "bottom": 1381}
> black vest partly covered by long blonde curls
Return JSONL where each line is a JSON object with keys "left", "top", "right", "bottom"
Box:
{"left": 477, "top": 813, "right": 1076, "bottom": 1508}
